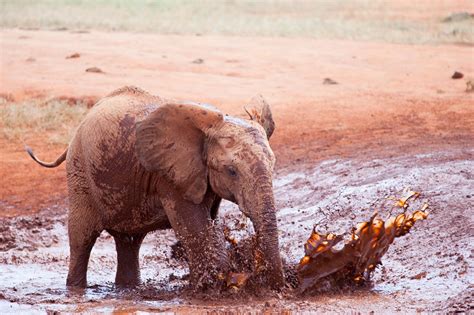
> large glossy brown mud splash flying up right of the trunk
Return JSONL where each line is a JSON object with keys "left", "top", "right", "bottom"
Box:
{"left": 297, "top": 191, "right": 428, "bottom": 292}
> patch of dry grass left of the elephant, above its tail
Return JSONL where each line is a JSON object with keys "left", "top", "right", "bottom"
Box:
{"left": 0, "top": 99, "right": 88, "bottom": 144}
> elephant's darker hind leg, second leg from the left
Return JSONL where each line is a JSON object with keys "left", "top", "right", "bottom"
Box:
{"left": 107, "top": 230, "right": 146, "bottom": 287}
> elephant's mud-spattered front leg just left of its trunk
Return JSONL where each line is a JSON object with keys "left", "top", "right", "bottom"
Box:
{"left": 163, "top": 199, "right": 229, "bottom": 289}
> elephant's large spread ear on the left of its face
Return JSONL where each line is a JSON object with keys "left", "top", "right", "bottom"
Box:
{"left": 136, "top": 103, "right": 223, "bottom": 204}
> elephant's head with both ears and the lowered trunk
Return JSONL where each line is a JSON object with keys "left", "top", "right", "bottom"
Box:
{"left": 133, "top": 98, "right": 283, "bottom": 287}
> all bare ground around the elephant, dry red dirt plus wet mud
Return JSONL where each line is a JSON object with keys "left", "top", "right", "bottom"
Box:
{"left": 0, "top": 25, "right": 474, "bottom": 313}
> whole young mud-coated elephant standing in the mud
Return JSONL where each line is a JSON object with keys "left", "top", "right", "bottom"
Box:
{"left": 27, "top": 87, "right": 283, "bottom": 288}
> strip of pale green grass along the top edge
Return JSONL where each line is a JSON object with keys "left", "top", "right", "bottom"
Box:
{"left": 0, "top": 0, "right": 474, "bottom": 43}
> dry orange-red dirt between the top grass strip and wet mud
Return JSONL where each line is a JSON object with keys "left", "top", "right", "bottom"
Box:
{"left": 0, "top": 30, "right": 474, "bottom": 216}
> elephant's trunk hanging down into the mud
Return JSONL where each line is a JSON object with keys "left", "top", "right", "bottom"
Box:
{"left": 245, "top": 177, "right": 284, "bottom": 288}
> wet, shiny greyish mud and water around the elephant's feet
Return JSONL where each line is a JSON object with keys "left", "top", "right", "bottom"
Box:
{"left": 0, "top": 151, "right": 474, "bottom": 313}
